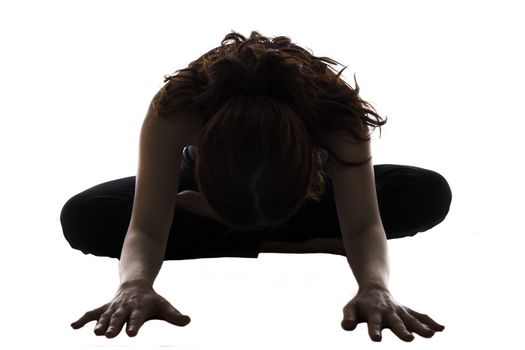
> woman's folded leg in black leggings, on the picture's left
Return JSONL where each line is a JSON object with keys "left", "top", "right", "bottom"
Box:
{"left": 60, "top": 173, "right": 259, "bottom": 260}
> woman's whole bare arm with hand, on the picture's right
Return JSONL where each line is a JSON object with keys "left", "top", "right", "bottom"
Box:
{"left": 328, "top": 133, "right": 444, "bottom": 341}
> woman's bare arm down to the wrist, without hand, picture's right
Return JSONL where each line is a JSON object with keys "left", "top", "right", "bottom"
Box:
{"left": 328, "top": 130, "right": 389, "bottom": 288}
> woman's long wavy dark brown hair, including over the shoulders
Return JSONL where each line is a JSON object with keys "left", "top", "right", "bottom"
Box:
{"left": 152, "top": 31, "right": 386, "bottom": 231}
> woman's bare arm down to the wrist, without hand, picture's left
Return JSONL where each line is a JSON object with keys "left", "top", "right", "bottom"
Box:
{"left": 119, "top": 111, "right": 200, "bottom": 286}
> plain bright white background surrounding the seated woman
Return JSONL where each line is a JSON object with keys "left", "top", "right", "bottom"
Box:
{"left": 0, "top": 0, "right": 525, "bottom": 349}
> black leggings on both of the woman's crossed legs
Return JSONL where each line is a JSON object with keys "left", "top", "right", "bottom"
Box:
{"left": 60, "top": 154, "right": 452, "bottom": 260}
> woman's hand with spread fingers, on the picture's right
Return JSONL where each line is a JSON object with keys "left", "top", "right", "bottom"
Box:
{"left": 341, "top": 287, "right": 445, "bottom": 342}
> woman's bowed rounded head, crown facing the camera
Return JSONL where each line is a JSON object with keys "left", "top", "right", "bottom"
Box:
{"left": 196, "top": 94, "right": 324, "bottom": 230}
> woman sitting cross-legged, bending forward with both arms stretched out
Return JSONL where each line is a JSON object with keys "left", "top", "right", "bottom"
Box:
{"left": 61, "top": 32, "right": 452, "bottom": 341}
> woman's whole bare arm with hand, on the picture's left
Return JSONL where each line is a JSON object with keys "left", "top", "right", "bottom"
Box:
{"left": 71, "top": 102, "right": 204, "bottom": 338}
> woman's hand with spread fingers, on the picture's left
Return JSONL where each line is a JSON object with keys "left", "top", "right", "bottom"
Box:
{"left": 71, "top": 282, "right": 191, "bottom": 338}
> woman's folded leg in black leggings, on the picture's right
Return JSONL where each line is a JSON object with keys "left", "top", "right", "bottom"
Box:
{"left": 261, "top": 164, "right": 452, "bottom": 255}
